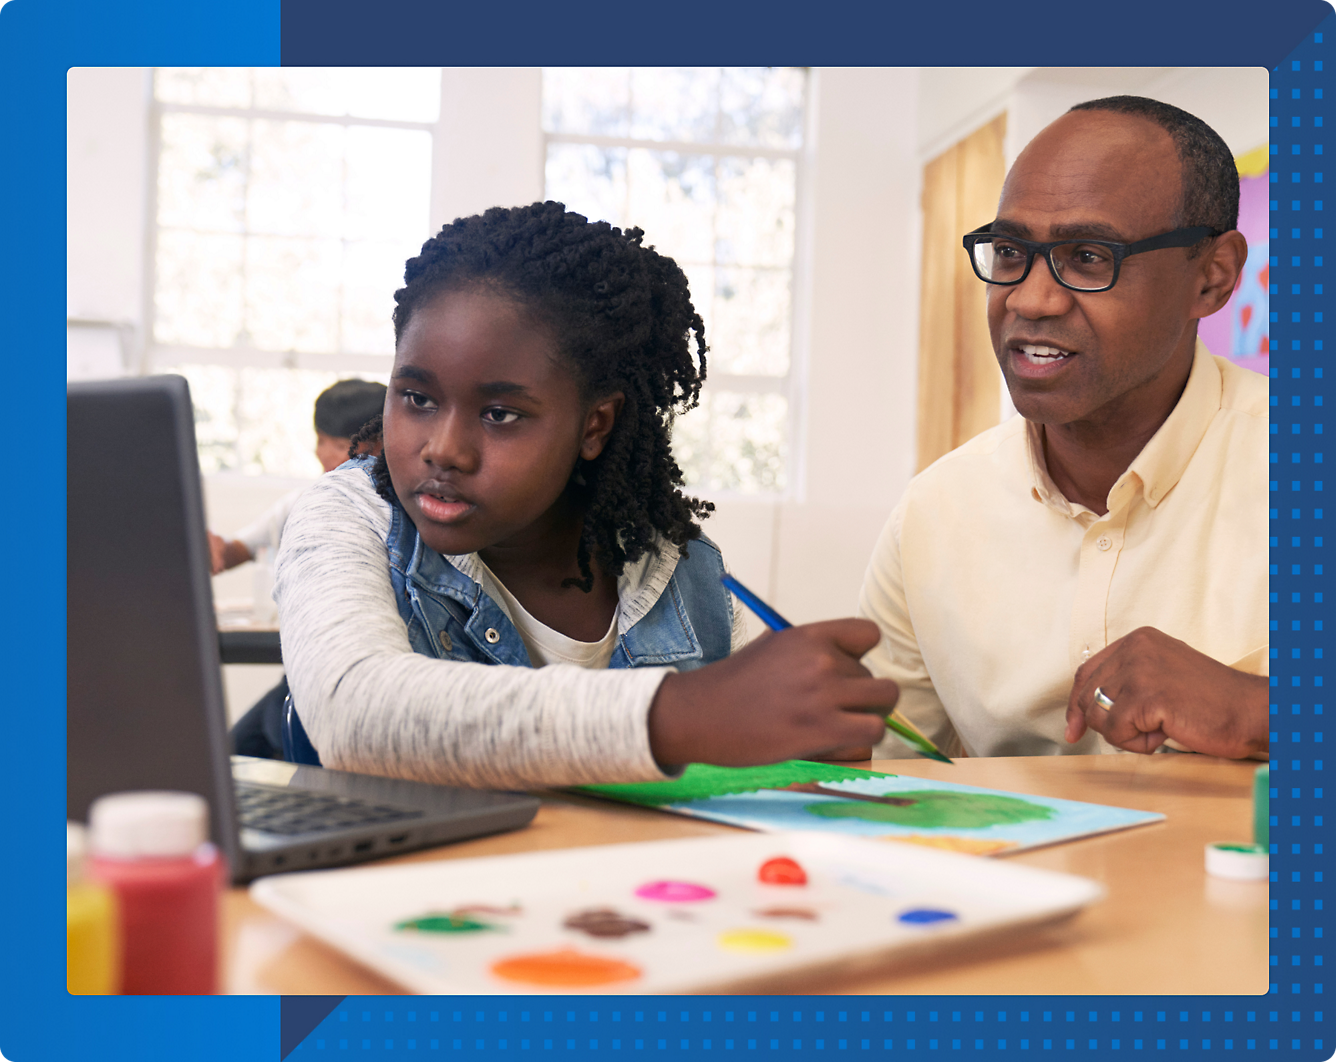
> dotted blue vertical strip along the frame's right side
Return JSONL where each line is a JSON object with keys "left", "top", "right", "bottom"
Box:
{"left": 1265, "top": 17, "right": 1336, "bottom": 1058}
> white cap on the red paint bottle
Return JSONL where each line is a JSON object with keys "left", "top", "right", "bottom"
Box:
{"left": 88, "top": 792, "right": 208, "bottom": 859}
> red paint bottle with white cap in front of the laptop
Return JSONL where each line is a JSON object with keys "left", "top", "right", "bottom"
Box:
{"left": 88, "top": 792, "right": 226, "bottom": 995}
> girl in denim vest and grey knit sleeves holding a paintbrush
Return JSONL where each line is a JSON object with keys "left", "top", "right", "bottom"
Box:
{"left": 275, "top": 203, "right": 896, "bottom": 788}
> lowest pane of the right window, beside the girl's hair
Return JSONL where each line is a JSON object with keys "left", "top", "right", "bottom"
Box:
{"left": 672, "top": 387, "right": 788, "bottom": 494}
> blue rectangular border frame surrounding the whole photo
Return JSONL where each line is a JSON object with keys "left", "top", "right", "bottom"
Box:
{"left": 0, "top": 0, "right": 1336, "bottom": 1062}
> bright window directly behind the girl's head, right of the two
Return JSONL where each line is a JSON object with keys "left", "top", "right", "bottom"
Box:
{"left": 542, "top": 68, "right": 807, "bottom": 493}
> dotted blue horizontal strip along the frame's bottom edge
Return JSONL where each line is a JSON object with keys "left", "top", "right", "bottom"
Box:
{"left": 289, "top": 997, "right": 1333, "bottom": 1062}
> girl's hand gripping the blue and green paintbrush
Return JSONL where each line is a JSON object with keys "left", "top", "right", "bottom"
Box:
{"left": 649, "top": 620, "right": 900, "bottom": 767}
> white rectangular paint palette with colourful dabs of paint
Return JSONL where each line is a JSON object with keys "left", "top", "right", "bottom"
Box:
{"left": 251, "top": 834, "right": 1104, "bottom": 994}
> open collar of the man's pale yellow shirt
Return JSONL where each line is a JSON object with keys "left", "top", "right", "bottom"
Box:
{"left": 1025, "top": 339, "right": 1224, "bottom": 518}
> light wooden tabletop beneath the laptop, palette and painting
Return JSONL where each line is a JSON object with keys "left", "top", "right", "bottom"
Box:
{"left": 223, "top": 753, "right": 1268, "bottom": 995}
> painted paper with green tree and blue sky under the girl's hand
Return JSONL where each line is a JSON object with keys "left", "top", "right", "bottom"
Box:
{"left": 581, "top": 760, "right": 1164, "bottom": 855}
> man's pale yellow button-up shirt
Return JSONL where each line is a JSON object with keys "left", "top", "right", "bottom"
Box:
{"left": 860, "top": 343, "right": 1268, "bottom": 756}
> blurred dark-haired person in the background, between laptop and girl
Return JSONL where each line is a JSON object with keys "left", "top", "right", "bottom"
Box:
{"left": 208, "top": 379, "right": 385, "bottom": 576}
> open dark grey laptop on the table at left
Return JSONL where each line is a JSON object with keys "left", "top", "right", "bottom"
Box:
{"left": 65, "top": 375, "right": 538, "bottom": 882}
